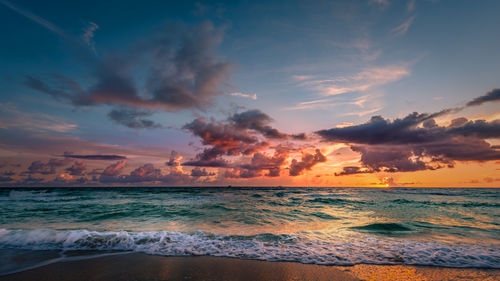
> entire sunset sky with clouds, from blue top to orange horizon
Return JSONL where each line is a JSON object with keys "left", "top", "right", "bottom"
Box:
{"left": 0, "top": 0, "right": 500, "bottom": 187}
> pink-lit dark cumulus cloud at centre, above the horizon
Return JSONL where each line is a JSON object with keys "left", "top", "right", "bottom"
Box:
{"left": 182, "top": 110, "right": 312, "bottom": 178}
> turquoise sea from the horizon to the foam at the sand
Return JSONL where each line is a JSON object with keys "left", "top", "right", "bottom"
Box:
{"left": 0, "top": 187, "right": 500, "bottom": 268}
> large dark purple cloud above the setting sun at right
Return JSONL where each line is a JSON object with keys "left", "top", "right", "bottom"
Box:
{"left": 317, "top": 111, "right": 500, "bottom": 175}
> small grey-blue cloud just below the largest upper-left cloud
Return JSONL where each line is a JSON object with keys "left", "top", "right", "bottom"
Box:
{"left": 108, "top": 109, "right": 162, "bottom": 129}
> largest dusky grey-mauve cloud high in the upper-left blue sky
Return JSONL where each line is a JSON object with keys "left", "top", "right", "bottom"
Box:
{"left": 24, "top": 22, "right": 231, "bottom": 111}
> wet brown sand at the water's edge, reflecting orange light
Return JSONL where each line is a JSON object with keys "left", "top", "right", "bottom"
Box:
{"left": 0, "top": 253, "right": 500, "bottom": 281}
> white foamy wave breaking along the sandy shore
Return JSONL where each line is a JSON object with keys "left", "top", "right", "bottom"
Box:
{"left": 0, "top": 229, "right": 500, "bottom": 268}
